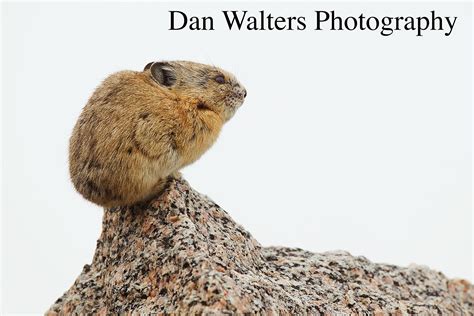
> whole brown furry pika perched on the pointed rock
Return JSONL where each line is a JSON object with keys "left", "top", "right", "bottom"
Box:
{"left": 69, "top": 61, "right": 247, "bottom": 208}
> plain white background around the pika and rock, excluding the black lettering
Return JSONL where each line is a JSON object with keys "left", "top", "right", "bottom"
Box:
{"left": 2, "top": 3, "right": 472, "bottom": 313}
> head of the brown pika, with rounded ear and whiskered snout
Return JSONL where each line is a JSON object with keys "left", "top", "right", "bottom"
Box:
{"left": 143, "top": 61, "right": 247, "bottom": 121}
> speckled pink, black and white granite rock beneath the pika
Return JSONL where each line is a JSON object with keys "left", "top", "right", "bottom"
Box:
{"left": 47, "top": 179, "right": 474, "bottom": 315}
